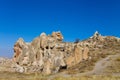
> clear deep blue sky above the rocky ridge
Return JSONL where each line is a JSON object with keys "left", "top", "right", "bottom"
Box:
{"left": 0, "top": 0, "right": 120, "bottom": 57}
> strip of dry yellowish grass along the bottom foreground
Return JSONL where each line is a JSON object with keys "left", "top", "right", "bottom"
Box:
{"left": 0, "top": 73, "right": 120, "bottom": 80}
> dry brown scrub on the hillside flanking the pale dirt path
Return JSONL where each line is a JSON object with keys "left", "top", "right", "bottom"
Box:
{"left": 67, "top": 39, "right": 120, "bottom": 74}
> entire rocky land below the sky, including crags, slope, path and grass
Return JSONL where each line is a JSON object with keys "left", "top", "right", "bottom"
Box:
{"left": 0, "top": 32, "right": 120, "bottom": 80}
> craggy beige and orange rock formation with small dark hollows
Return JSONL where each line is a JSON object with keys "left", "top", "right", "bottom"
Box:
{"left": 10, "top": 31, "right": 120, "bottom": 74}
